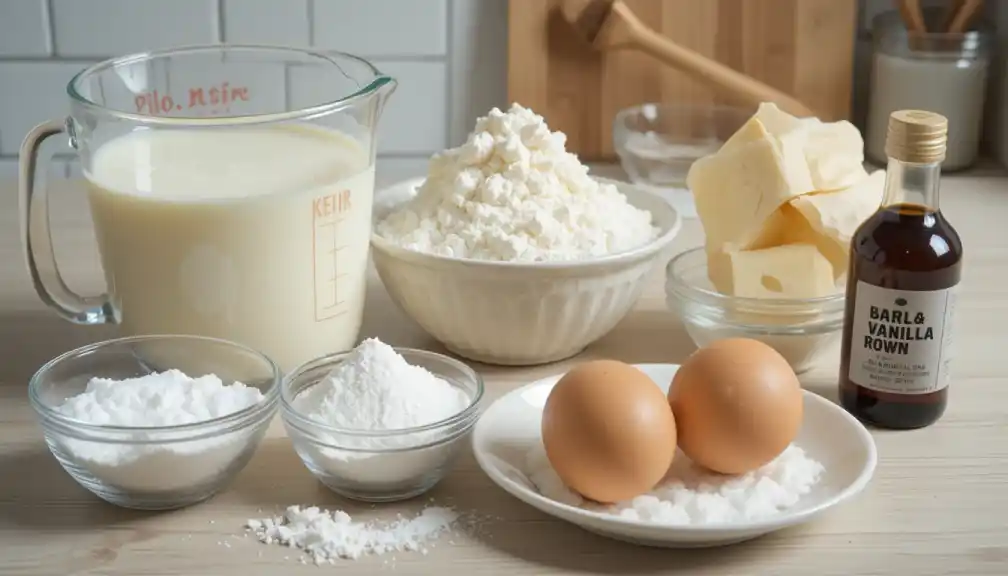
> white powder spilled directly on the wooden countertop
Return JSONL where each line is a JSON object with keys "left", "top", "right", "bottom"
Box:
{"left": 245, "top": 506, "right": 459, "bottom": 564}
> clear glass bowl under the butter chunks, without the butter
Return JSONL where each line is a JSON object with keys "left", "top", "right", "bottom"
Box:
{"left": 665, "top": 247, "right": 845, "bottom": 373}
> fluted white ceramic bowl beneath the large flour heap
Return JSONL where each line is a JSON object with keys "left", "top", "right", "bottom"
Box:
{"left": 371, "top": 179, "right": 681, "bottom": 365}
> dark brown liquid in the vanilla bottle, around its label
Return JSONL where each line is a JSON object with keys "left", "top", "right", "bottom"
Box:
{"left": 840, "top": 204, "right": 963, "bottom": 429}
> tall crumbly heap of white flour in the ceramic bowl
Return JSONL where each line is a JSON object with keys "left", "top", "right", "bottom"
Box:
{"left": 376, "top": 104, "right": 658, "bottom": 261}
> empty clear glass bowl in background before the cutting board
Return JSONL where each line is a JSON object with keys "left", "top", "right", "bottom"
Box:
{"left": 613, "top": 103, "right": 754, "bottom": 218}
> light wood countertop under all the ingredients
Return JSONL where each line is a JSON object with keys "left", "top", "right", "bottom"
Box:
{"left": 0, "top": 171, "right": 1008, "bottom": 576}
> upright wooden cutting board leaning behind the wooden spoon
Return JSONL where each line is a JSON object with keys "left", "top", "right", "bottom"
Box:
{"left": 508, "top": 0, "right": 858, "bottom": 160}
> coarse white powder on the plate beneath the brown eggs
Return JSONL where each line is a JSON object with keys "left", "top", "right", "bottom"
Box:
{"left": 525, "top": 443, "right": 824, "bottom": 526}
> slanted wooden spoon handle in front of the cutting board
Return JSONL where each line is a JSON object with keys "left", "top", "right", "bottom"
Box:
{"left": 633, "top": 28, "right": 814, "bottom": 116}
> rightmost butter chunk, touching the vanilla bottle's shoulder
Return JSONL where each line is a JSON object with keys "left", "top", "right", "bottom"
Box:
{"left": 791, "top": 170, "right": 885, "bottom": 258}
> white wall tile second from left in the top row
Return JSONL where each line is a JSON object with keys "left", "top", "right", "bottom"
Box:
{"left": 51, "top": 0, "right": 220, "bottom": 57}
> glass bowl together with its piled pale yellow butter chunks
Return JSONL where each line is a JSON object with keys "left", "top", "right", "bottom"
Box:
{"left": 666, "top": 103, "right": 886, "bottom": 372}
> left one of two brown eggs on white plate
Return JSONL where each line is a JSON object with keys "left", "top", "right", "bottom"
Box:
{"left": 542, "top": 360, "right": 675, "bottom": 502}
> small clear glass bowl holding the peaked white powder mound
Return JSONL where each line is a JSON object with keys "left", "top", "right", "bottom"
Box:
{"left": 280, "top": 348, "right": 483, "bottom": 502}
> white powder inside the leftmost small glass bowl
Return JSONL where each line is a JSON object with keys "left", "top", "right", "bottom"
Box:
{"left": 55, "top": 370, "right": 263, "bottom": 492}
